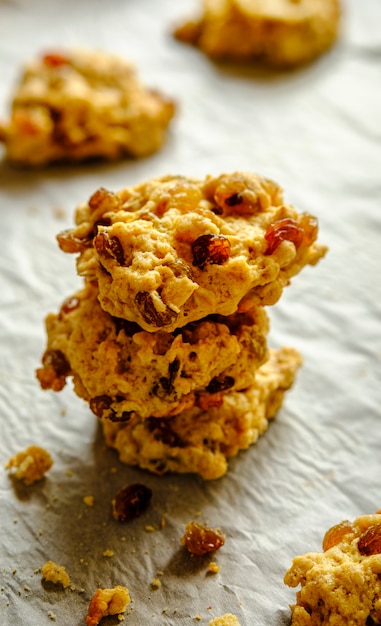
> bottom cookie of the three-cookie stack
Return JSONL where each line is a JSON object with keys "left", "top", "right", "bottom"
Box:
{"left": 102, "top": 348, "right": 301, "bottom": 480}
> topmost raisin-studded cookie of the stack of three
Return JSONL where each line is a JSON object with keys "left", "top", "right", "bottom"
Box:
{"left": 58, "top": 172, "right": 326, "bottom": 332}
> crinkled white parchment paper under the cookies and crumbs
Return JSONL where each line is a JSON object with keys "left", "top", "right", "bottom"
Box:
{"left": 0, "top": 0, "right": 381, "bottom": 626}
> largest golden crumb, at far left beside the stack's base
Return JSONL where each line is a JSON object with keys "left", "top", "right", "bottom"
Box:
{"left": 5, "top": 445, "right": 53, "bottom": 485}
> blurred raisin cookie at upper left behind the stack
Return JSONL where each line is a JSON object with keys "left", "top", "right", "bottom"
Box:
{"left": 0, "top": 50, "right": 175, "bottom": 166}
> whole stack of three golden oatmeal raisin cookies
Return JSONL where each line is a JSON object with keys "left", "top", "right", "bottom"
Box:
{"left": 37, "top": 172, "right": 326, "bottom": 479}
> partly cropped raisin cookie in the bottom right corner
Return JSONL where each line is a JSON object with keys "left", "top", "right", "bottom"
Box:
{"left": 284, "top": 513, "right": 381, "bottom": 626}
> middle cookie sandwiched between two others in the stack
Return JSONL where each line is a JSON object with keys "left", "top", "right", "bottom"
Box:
{"left": 37, "top": 283, "right": 268, "bottom": 420}
